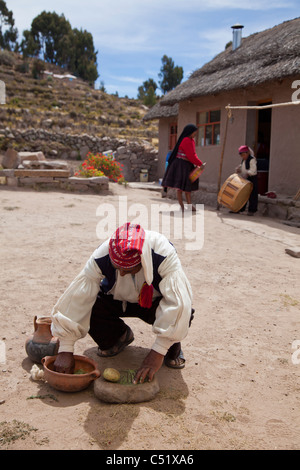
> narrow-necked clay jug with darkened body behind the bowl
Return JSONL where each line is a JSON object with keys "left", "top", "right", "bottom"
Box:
{"left": 25, "top": 316, "right": 59, "bottom": 363}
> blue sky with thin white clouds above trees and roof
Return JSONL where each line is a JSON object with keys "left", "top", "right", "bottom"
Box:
{"left": 6, "top": 0, "right": 300, "bottom": 98}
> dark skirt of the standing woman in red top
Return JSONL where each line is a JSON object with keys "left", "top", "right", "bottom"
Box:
{"left": 162, "top": 158, "right": 199, "bottom": 193}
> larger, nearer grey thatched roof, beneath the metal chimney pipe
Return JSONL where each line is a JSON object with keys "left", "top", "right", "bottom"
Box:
{"left": 156, "top": 18, "right": 300, "bottom": 107}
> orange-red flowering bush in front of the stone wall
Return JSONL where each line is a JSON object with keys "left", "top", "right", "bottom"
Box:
{"left": 75, "top": 152, "right": 125, "bottom": 183}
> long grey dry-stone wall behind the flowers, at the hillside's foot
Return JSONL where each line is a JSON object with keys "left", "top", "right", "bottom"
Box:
{"left": 0, "top": 127, "right": 158, "bottom": 181}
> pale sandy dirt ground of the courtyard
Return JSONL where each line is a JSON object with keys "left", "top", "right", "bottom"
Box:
{"left": 0, "top": 185, "right": 300, "bottom": 450}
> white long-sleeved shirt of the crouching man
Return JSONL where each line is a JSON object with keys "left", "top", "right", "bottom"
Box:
{"left": 51, "top": 230, "right": 192, "bottom": 355}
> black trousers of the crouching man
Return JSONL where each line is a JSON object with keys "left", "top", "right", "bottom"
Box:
{"left": 89, "top": 292, "right": 193, "bottom": 358}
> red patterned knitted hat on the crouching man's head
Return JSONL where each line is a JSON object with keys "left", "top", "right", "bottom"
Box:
{"left": 109, "top": 222, "right": 145, "bottom": 269}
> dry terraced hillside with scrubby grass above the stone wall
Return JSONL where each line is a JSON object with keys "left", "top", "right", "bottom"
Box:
{"left": 0, "top": 51, "right": 158, "bottom": 151}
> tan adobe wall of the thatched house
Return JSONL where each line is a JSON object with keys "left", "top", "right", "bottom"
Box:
{"left": 158, "top": 78, "right": 300, "bottom": 196}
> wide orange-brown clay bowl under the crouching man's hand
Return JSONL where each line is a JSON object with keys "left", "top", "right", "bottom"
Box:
{"left": 42, "top": 355, "right": 100, "bottom": 392}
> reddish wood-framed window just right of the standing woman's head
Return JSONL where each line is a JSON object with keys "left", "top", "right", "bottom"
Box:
{"left": 197, "top": 109, "right": 221, "bottom": 147}
